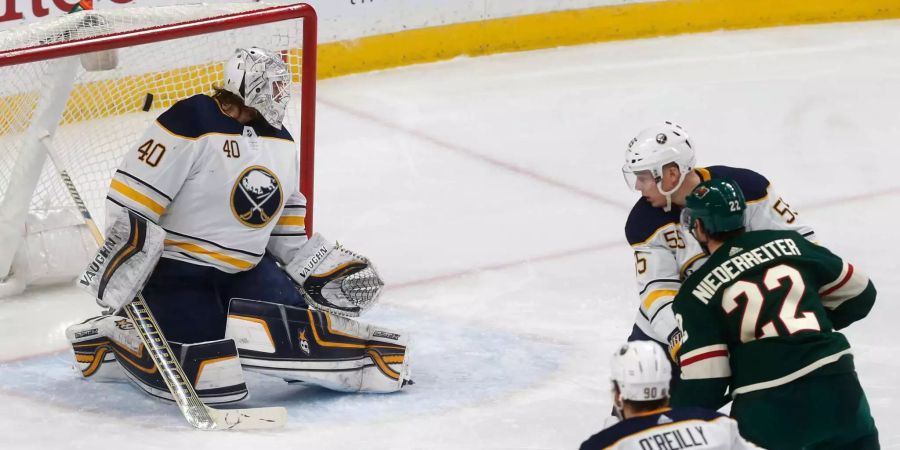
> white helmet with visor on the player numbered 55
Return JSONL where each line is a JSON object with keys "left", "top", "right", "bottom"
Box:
{"left": 622, "top": 122, "right": 697, "bottom": 211}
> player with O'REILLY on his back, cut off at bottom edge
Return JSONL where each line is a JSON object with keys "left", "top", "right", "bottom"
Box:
{"left": 581, "top": 341, "right": 759, "bottom": 450}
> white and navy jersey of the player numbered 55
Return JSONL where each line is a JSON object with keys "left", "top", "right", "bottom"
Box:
{"left": 625, "top": 166, "right": 815, "bottom": 355}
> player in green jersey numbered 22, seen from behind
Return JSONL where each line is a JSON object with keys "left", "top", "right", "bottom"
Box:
{"left": 672, "top": 179, "right": 879, "bottom": 449}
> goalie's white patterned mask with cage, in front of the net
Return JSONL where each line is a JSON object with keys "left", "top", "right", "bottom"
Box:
{"left": 224, "top": 47, "right": 291, "bottom": 129}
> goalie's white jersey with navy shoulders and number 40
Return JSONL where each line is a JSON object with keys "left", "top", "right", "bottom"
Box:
{"left": 106, "top": 95, "right": 307, "bottom": 273}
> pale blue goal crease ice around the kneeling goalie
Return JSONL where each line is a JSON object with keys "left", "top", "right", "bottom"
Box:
{"left": 0, "top": 306, "right": 564, "bottom": 427}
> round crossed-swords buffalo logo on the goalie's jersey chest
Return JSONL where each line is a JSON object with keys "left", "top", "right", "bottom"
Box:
{"left": 231, "top": 166, "right": 283, "bottom": 228}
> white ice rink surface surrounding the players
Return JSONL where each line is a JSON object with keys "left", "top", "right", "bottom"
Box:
{"left": 0, "top": 21, "right": 900, "bottom": 449}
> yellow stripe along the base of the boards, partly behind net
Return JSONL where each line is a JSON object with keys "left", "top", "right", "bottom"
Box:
{"left": 0, "top": 0, "right": 900, "bottom": 136}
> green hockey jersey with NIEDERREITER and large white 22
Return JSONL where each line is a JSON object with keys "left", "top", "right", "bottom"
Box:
{"left": 672, "top": 231, "right": 875, "bottom": 409}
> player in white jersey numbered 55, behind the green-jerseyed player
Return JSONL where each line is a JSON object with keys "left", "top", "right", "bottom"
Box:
{"left": 622, "top": 122, "right": 815, "bottom": 368}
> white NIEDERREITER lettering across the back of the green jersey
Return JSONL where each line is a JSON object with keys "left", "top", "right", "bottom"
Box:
{"left": 691, "top": 238, "right": 800, "bottom": 304}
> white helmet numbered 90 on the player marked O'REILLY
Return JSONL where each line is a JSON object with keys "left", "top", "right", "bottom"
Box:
{"left": 610, "top": 341, "right": 672, "bottom": 402}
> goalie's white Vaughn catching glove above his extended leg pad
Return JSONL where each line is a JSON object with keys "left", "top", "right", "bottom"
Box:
{"left": 285, "top": 233, "right": 384, "bottom": 317}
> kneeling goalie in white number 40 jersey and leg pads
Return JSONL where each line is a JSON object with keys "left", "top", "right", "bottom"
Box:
{"left": 67, "top": 47, "right": 409, "bottom": 403}
